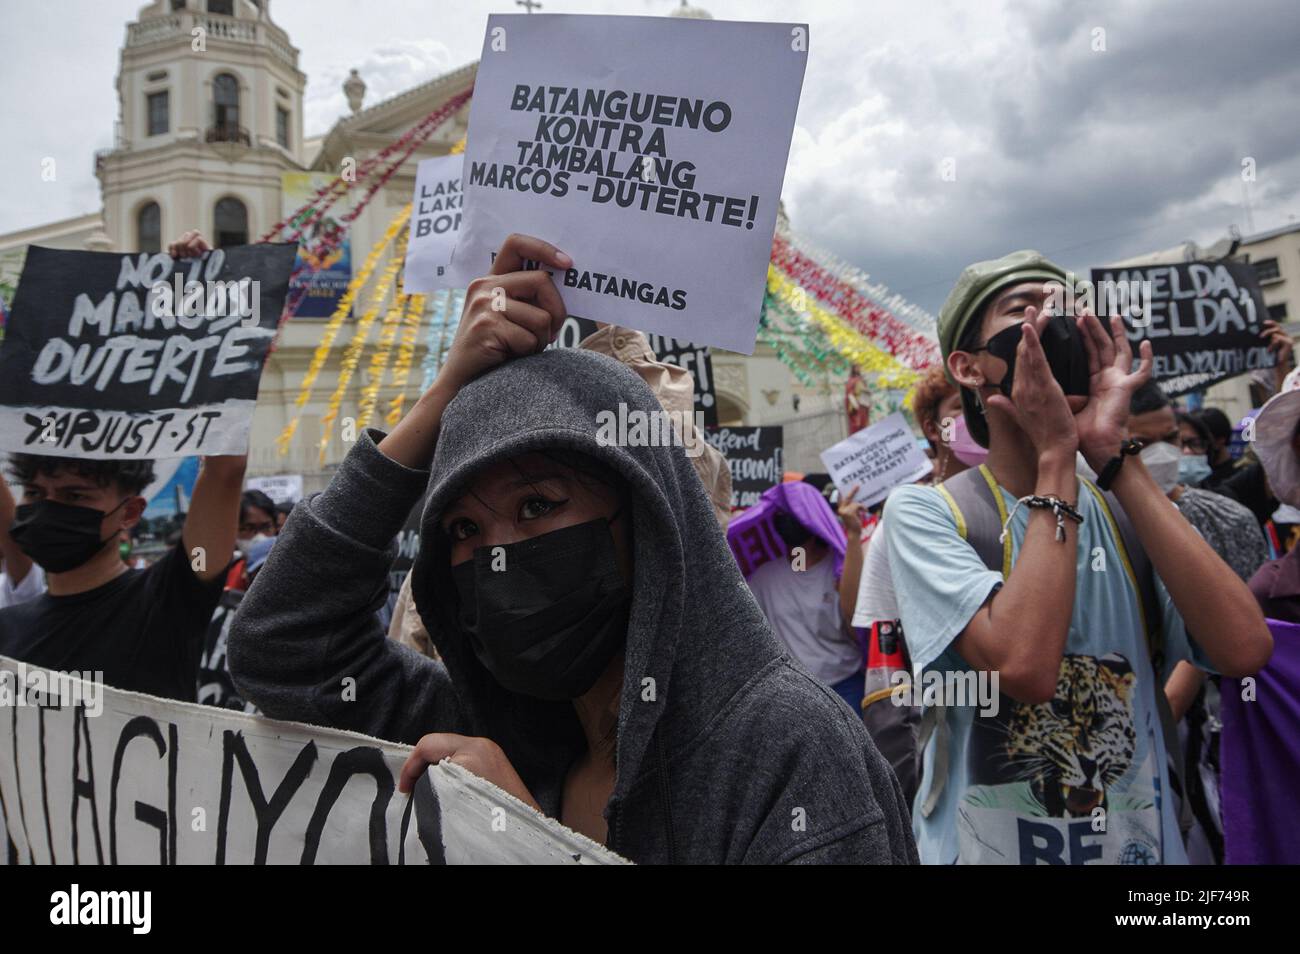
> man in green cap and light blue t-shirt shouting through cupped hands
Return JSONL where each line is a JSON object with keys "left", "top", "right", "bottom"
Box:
{"left": 884, "top": 251, "right": 1273, "bottom": 864}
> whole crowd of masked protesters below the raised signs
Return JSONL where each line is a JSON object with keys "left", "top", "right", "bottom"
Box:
{"left": 0, "top": 233, "right": 1300, "bottom": 864}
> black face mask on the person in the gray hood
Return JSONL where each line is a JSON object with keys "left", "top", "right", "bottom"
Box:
{"left": 451, "top": 515, "right": 632, "bottom": 701}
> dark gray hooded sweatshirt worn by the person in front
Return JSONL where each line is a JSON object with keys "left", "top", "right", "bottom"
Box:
{"left": 229, "top": 350, "right": 917, "bottom": 863}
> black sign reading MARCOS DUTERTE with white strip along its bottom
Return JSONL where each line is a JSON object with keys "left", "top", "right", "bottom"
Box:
{"left": 0, "top": 243, "right": 296, "bottom": 459}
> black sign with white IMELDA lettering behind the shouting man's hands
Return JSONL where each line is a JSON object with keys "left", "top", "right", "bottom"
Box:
{"left": 1092, "top": 261, "right": 1277, "bottom": 396}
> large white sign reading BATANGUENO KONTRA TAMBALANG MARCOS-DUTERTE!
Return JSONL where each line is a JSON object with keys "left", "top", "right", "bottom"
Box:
{"left": 451, "top": 14, "right": 809, "bottom": 355}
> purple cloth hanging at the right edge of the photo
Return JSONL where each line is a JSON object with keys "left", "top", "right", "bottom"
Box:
{"left": 1219, "top": 619, "right": 1300, "bottom": 864}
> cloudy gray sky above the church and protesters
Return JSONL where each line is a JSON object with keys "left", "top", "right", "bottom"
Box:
{"left": 0, "top": 0, "right": 1300, "bottom": 312}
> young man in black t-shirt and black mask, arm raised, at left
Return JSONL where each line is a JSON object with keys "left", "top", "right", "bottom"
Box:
{"left": 0, "top": 454, "right": 247, "bottom": 702}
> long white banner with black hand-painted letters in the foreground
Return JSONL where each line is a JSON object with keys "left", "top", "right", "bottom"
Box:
{"left": 0, "top": 656, "right": 623, "bottom": 864}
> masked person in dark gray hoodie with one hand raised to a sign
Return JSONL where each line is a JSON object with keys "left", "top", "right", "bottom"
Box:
{"left": 229, "top": 235, "right": 917, "bottom": 863}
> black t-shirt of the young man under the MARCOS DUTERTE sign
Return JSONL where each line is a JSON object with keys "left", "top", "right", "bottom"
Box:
{"left": 0, "top": 543, "right": 222, "bottom": 702}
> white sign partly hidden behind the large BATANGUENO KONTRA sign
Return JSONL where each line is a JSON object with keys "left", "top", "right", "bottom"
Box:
{"left": 402, "top": 155, "right": 470, "bottom": 295}
